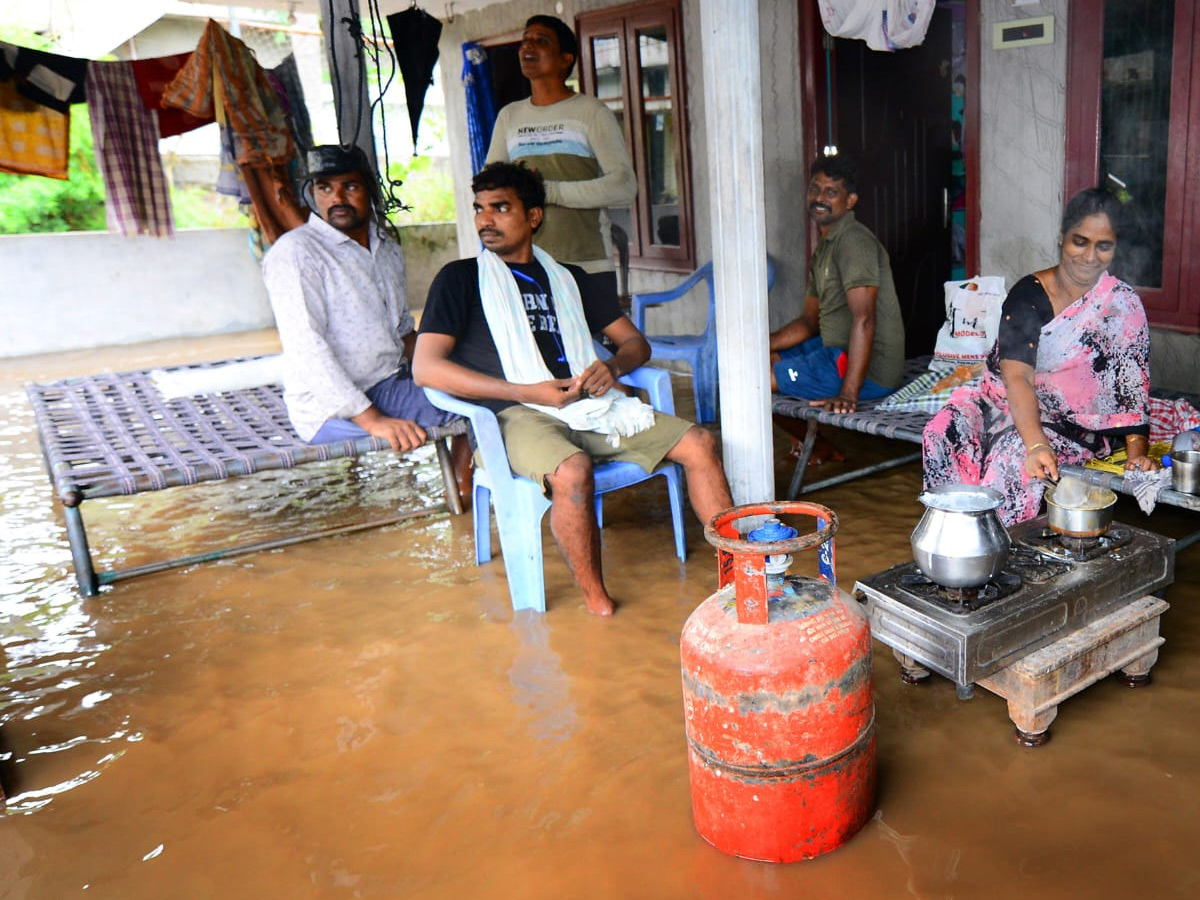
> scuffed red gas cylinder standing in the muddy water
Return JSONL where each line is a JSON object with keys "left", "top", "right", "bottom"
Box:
{"left": 680, "top": 502, "right": 875, "bottom": 863}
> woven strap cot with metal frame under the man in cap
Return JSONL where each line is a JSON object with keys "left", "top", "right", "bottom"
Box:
{"left": 25, "top": 360, "right": 468, "bottom": 596}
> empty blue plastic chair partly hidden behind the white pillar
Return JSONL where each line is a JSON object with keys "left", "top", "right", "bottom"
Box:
{"left": 629, "top": 257, "right": 775, "bottom": 422}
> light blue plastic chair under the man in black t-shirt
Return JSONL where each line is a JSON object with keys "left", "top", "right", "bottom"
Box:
{"left": 425, "top": 366, "right": 688, "bottom": 612}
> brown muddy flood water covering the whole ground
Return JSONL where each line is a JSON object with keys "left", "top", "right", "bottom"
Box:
{"left": 0, "top": 332, "right": 1200, "bottom": 900}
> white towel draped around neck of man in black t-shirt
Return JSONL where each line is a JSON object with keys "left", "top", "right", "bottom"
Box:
{"left": 479, "top": 246, "right": 654, "bottom": 446}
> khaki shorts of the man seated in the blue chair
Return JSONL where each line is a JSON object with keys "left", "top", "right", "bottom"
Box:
{"left": 496, "top": 403, "right": 691, "bottom": 490}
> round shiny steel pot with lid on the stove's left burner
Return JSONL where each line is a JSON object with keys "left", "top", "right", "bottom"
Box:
{"left": 911, "top": 485, "right": 1010, "bottom": 588}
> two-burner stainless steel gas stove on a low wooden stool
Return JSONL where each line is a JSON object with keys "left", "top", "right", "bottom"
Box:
{"left": 854, "top": 516, "right": 1175, "bottom": 698}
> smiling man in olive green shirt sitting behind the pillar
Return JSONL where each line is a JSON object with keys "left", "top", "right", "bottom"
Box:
{"left": 770, "top": 156, "right": 904, "bottom": 413}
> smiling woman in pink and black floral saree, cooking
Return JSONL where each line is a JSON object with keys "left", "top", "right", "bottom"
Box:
{"left": 924, "top": 188, "right": 1158, "bottom": 524}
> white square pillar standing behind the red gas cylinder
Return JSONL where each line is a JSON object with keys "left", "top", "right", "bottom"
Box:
{"left": 700, "top": 0, "right": 775, "bottom": 504}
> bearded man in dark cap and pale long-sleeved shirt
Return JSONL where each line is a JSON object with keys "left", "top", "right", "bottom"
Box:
{"left": 263, "top": 145, "right": 469, "bottom": 493}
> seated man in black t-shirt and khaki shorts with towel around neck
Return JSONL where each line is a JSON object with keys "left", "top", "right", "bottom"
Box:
{"left": 413, "top": 162, "right": 733, "bottom": 616}
